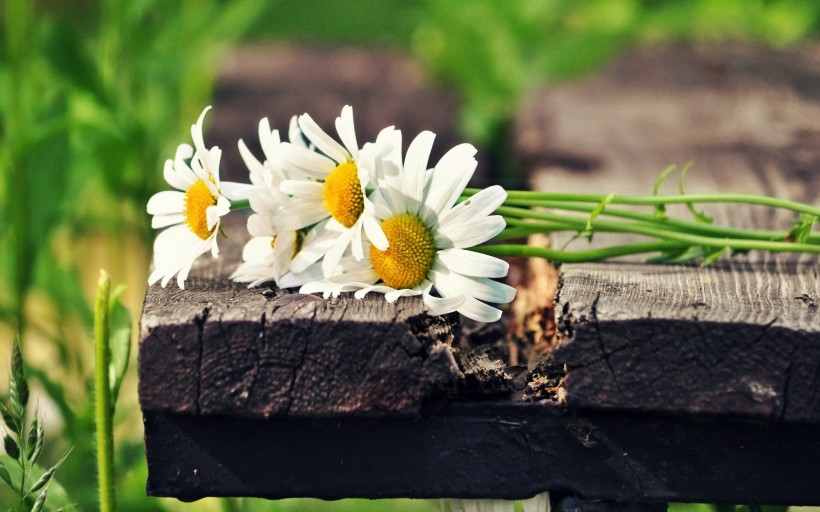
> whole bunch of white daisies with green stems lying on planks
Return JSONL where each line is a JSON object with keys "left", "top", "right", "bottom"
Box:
{"left": 147, "top": 106, "right": 820, "bottom": 322}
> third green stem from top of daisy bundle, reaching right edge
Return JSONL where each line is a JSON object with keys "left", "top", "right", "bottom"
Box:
{"left": 497, "top": 206, "right": 820, "bottom": 254}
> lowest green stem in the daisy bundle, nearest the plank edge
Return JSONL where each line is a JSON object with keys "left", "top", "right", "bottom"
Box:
{"left": 471, "top": 242, "right": 685, "bottom": 263}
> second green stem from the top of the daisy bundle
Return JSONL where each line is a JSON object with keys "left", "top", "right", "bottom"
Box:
{"left": 496, "top": 199, "right": 820, "bottom": 243}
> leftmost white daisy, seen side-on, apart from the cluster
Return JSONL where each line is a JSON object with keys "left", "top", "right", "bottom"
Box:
{"left": 146, "top": 107, "right": 250, "bottom": 288}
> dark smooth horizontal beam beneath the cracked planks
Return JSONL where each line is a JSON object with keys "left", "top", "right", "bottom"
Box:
{"left": 145, "top": 401, "right": 820, "bottom": 504}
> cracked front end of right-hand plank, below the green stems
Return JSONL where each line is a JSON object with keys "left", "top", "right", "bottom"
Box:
{"left": 554, "top": 262, "right": 820, "bottom": 422}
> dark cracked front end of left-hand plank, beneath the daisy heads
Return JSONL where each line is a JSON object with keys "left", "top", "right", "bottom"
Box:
{"left": 139, "top": 230, "right": 460, "bottom": 418}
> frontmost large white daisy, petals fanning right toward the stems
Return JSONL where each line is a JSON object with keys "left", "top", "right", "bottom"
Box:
{"left": 300, "top": 132, "right": 515, "bottom": 322}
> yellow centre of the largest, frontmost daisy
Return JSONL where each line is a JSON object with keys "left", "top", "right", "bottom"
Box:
{"left": 370, "top": 213, "right": 436, "bottom": 290}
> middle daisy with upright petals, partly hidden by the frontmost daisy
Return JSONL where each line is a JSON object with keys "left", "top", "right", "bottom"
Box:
{"left": 275, "top": 105, "right": 393, "bottom": 275}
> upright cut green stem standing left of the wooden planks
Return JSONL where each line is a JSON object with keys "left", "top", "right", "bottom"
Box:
{"left": 94, "top": 270, "right": 116, "bottom": 512}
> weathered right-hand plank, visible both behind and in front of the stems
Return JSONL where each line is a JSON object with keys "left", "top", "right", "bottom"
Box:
{"left": 517, "top": 46, "right": 820, "bottom": 421}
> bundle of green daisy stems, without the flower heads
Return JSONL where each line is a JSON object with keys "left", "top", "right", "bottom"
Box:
{"left": 464, "top": 187, "right": 820, "bottom": 266}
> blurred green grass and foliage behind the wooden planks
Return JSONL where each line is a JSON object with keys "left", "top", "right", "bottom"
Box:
{"left": 0, "top": 0, "right": 820, "bottom": 511}
